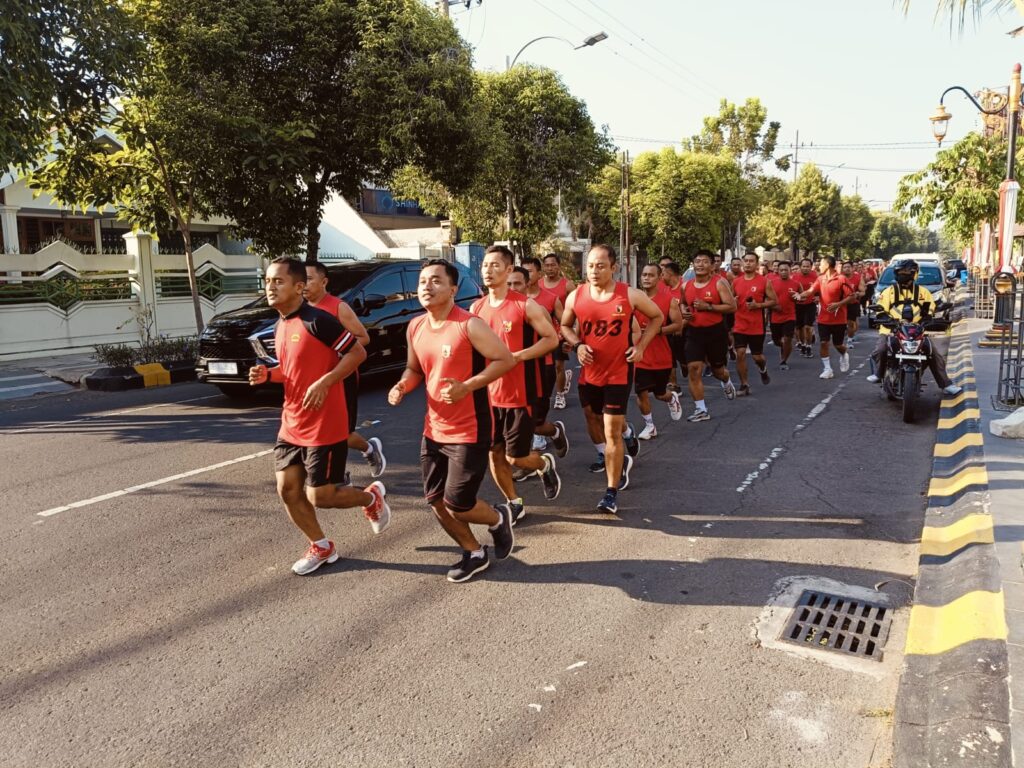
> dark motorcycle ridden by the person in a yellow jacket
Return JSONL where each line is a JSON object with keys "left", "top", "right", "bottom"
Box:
{"left": 870, "top": 301, "right": 950, "bottom": 424}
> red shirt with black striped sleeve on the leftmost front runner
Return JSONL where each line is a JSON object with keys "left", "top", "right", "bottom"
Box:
{"left": 273, "top": 301, "right": 356, "bottom": 447}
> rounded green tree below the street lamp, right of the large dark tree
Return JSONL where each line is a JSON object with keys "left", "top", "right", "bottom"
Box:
{"left": 393, "top": 65, "right": 611, "bottom": 252}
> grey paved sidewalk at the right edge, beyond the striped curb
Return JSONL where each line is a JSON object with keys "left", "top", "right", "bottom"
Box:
{"left": 970, "top": 319, "right": 1024, "bottom": 765}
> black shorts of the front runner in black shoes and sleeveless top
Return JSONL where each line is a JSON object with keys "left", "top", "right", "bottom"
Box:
{"left": 420, "top": 435, "right": 489, "bottom": 512}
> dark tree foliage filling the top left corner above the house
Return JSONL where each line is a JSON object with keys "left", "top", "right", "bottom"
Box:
{"left": 0, "top": 0, "right": 138, "bottom": 169}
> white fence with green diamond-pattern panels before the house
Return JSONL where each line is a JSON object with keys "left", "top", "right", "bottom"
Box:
{"left": 0, "top": 233, "right": 262, "bottom": 359}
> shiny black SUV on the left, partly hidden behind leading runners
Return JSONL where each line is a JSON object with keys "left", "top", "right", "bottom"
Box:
{"left": 196, "top": 259, "right": 482, "bottom": 396}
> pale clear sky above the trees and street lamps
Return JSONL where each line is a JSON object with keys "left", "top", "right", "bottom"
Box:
{"left": 452, "top": 0, "right": 1024, "bottom": 214}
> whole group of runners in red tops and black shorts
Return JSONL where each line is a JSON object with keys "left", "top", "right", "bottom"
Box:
{"left": 249, "top": 245, "right": 897, "bottom": 582}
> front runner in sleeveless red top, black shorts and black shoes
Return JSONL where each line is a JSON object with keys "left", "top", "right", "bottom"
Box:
{"left": 388, "top": 259, "right": 515, "bottom": 582}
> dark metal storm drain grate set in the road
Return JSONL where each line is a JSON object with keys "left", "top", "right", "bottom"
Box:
{"left": 779, "top": 590, "right": 893, "bottom": 662}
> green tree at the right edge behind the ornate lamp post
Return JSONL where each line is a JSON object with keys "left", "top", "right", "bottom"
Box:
{"left": 893, "top": 133, "right": 1024, "bottom": 243}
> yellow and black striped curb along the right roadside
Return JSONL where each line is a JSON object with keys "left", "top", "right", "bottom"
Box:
{"left": 893, "top": 323, "right": 1012, "bottom": 768}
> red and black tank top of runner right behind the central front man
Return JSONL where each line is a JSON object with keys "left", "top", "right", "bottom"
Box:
{"left": 470, "top": 291, "right": 541, "bottom": 408}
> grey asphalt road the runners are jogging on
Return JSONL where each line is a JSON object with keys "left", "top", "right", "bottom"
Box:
{"left": 0, "top": 334, "right": 939, "bottom": 768}
